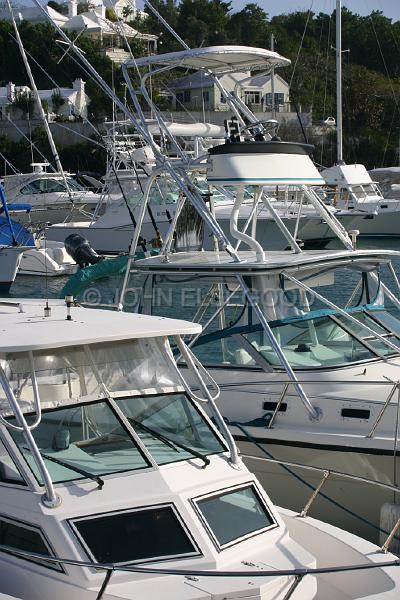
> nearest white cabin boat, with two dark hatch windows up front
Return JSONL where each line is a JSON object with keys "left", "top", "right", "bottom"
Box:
{"left": 0, "top": 297, "right": 400, "bottom": 600}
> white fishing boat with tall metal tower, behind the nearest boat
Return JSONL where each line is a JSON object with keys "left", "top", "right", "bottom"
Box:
{"left": 33, "top": 0, "right": 400, "bottom": 552}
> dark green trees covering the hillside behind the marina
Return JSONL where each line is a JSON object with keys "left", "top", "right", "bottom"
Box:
{"left": 0, "top": 0, "right": 400, "bottom": 166}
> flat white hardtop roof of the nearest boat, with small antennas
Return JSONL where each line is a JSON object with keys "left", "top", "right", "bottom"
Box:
{"left": 0, "top": 299, "right": 201, "bottom": 353}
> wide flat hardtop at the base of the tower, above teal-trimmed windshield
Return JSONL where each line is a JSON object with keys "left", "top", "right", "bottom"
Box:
{"left": 135, "top": 250, "right": 400, "bottom": 276}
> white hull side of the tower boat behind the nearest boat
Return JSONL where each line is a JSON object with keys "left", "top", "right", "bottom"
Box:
{"left": 203, "top": 360, "right": 400, "bottom": 543}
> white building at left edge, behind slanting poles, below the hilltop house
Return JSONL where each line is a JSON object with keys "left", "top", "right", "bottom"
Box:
{"left": 0, "top": 79, "right": 90, "bottom": 119}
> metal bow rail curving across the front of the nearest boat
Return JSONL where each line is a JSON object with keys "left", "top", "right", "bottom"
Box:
{"left": 0, "top": 544, "right": 400, "bottom": 600}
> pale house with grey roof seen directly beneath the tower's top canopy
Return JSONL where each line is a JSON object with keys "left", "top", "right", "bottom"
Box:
{"left": 168, "top": 71, "right": 290, "bottom": 112}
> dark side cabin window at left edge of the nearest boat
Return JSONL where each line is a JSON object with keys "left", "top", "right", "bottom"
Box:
{"left": 0, "top": 515, "right": 62, "bottom": 571}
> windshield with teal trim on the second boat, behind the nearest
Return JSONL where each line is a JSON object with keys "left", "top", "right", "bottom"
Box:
{"left": 196, "top": 307, "right": 400, "bottom": 369}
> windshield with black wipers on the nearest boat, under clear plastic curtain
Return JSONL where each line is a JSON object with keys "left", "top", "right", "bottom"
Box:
{"left": 10, "top": 393, "right": 226, "bottom": 484}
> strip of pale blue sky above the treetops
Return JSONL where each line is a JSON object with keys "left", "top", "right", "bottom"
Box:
{"left": 228, "top": 0, "right": 400, "bottom": 21}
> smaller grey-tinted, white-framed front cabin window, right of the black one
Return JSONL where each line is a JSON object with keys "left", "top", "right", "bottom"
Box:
{"left": 194, "top": 485, "right": 277, "bottom": 548}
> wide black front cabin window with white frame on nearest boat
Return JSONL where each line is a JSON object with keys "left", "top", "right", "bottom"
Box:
{"left": 71, "top": 505, "right": 200, "bottom": 564}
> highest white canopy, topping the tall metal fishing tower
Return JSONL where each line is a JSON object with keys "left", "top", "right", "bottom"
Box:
{"left": 125, "top": 46, "right": 290, "bottom": 75}
